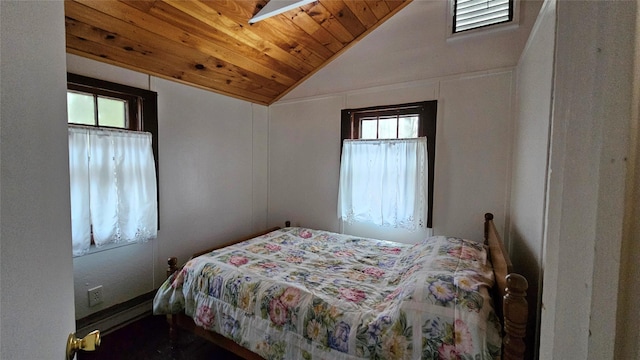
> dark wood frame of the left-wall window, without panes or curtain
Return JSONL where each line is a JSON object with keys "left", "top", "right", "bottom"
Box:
{"left": 67, "top": 73, "right": 160, "bottom": 230}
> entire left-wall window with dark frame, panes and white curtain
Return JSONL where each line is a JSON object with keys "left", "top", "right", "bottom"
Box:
{"left": 67, "top": 74, "right": 158, "bottom": 256}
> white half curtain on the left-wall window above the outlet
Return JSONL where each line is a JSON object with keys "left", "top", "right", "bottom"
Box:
{"left": 69, "top": 126, "right": 158, "bottom": 256}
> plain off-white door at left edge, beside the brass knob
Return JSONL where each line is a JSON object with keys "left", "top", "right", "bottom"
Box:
{"left": 0, "top": 1, "right": 75, "bottom": 360}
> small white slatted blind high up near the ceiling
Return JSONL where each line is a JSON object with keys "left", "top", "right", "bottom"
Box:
{"left": 453, "top": 0, "right": 514, "bottom": 33}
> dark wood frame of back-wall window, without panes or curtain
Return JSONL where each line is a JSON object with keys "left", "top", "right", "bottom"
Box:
{"left": 340, "top": 100, "right": 438, "bottom": 228}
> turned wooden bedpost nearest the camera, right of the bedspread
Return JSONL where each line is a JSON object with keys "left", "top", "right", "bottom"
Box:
{"left": 503, "top": 273, "right": 529, "bottom": 360}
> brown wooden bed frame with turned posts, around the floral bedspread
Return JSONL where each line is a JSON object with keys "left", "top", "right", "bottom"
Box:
{"left": 167, "top": 213, "right": 528, "bottom": 360}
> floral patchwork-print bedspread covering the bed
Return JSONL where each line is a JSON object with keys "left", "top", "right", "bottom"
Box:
{"left": 153, "top": 228, "right": 501, "bottom": 360}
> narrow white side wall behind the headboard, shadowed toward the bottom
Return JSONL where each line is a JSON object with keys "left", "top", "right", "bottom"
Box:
{"left": 507, "top": 1, "right": 556, "bottom": 358}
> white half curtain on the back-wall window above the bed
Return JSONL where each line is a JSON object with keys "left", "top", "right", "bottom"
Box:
{"left": 338, "top": 138, "right": 428, "bottom": 230}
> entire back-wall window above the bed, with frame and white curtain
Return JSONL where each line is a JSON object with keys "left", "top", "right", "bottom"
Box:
{"left": 338, "top": 101, "right": 437, "bottom": 230}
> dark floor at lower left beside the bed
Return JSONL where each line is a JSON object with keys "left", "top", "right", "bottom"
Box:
{"left": 77, "top": 316, "right": 240, "bottom": 360}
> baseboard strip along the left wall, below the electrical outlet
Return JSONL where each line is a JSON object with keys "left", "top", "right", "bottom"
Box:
{"left": 76, "top": 290, "right": 156, "bottom": 337}
